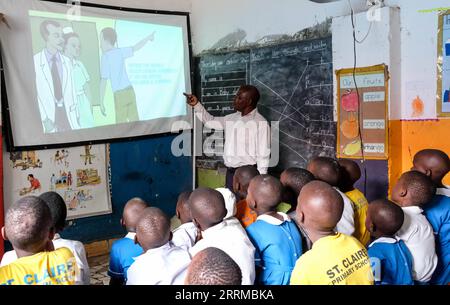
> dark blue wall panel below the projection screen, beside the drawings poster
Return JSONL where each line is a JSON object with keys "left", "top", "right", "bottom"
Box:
{"left": 62, "top": 135, "right": 192, "bottom": 242}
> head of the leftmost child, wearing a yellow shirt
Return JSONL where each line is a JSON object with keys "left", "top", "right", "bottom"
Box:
{"left": 5, "top": 196, "right": 52, "bottom": 252}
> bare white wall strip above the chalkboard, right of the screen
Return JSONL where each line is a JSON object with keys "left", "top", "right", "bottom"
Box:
{"left": 191, "top": 0, "right": 365, "bottom": 54}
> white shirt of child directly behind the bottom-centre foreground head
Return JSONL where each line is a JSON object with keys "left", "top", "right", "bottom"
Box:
{"left": 189, "top": 220, "right": 255, "bottom": 285}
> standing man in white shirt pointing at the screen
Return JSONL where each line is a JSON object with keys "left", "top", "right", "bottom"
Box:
{"left": 185, "top": 85, "right": 270, "bottom": 190}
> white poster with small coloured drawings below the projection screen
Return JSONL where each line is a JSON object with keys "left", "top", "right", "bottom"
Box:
{"left": 3, "top": 144, "right": 112, "bottom": 219}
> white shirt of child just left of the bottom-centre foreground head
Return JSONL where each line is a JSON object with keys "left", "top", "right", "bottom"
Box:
{"left": 127, "top": 241, "right": 191, "bottom": 285}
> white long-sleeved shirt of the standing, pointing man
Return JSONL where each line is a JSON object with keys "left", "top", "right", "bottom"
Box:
{"left": 194, "top": 102, "right": 271, "bottom": 174}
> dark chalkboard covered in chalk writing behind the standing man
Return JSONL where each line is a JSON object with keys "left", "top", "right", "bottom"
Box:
{"left": 196, "top": 37, "right": 336, "bottom": 172}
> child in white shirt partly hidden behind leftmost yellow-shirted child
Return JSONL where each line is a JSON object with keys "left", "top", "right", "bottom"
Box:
{"left": 0, "top": 192, "right": 90, "bottom": 285}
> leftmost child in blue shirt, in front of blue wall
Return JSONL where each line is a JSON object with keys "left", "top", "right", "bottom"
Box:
{"left": 108, "top": 197, "right": 148, "bottom": 285}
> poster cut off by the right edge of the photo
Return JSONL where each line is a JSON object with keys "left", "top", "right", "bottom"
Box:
{"left": 436, "top": 10, "right": 450, "bottom": 117}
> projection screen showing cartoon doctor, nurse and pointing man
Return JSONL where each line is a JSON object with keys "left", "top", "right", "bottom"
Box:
{"left": 0, "top": 0, "right": 191, "bottom": 147}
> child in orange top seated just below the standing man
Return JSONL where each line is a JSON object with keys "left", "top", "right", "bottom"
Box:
{"left": 233, "top": 165, "right": 259, "bottom": 228}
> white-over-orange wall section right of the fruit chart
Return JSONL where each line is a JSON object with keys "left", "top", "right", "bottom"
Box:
{"left": 386, "top": 0, "right": 450, "bottom": 188}
